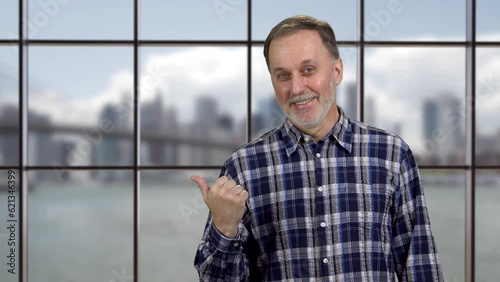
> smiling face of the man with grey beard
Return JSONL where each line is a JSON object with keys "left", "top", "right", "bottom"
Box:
{"left": 269, "top": 30, "right": 343, "bottom": 129}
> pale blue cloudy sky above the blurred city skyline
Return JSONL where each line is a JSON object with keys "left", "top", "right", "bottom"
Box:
{"left": 0, "top": 0, "right": 500, "bottom": 150}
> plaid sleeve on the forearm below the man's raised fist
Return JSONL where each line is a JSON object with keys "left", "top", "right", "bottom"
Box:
{"left": 194, "top": 164, "right": 249, "bottom": 281}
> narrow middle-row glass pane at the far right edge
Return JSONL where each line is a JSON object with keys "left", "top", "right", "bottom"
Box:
{"left": 476, "top": 48, "right": 500, "bottom": 165}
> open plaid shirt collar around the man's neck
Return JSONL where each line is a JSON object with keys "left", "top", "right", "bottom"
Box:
{"left": 281, "top": 107, "right": 352, "bottom": 156}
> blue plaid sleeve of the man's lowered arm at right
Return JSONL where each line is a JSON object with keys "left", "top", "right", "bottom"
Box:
{"left": 392, "top": 151, "right": 444, "bottom": 281}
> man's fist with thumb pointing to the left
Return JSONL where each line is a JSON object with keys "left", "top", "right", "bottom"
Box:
{"left": 191, "top": 175, "right": 248, "bottom": 238}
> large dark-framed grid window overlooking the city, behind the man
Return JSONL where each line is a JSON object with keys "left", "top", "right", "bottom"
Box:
{"left": 0, "top": 0, "right": 500, "bottom": 282}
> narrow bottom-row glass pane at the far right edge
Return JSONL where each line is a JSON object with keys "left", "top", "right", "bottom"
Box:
{"left": 476, "top": 170, "right": 500, "bottom": 281}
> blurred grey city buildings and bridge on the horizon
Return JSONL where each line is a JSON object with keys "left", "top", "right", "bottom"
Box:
{"left": 0, "top": 78, "right": 500, "bottom": 167}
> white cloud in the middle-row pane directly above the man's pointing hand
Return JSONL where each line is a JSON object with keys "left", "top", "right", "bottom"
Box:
{"left": 141, "top": 46, "right": 247, "bottom": 121}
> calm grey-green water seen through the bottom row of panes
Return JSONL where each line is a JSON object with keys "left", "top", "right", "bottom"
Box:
{"left": 0, "top": 174, "right": 500, "bottom": 282}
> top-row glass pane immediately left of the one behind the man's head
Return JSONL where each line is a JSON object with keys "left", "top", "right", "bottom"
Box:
{"left": 141, "top": 0, "right": 248, "bottom": 40}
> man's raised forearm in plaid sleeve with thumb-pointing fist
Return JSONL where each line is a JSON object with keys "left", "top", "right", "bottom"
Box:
{"left": 191, "top": 165, "right": 249, "bottom": 281}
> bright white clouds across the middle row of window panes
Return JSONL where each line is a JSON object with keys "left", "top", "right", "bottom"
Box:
{"left": 8, "top": 37, "right": 500, "bottom": 139}
